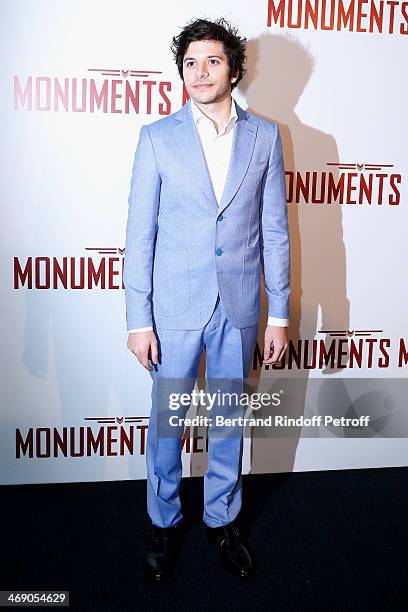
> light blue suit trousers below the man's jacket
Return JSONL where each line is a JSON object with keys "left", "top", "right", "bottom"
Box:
{"left": 146, "top": 296, "right": 258, "bottom": 527}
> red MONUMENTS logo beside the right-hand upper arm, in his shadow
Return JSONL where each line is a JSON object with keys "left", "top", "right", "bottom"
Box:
{"left": 285, "top": 162, "right": 402, "bottom": 206}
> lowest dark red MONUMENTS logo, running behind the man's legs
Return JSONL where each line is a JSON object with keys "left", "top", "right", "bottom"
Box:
{"left": 15, "top": 416, "right": 208, "bottom": 459}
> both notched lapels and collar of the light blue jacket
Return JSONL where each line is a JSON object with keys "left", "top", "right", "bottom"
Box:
{"left": 174, "top": 100, "right": 257, "bottom": 212}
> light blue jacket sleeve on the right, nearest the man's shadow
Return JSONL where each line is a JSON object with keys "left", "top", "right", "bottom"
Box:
{"left": 261, "top": 124, "right": 291, "bottom": 319}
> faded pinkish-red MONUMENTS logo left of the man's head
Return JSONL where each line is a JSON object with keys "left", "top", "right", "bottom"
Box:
{"left": 13, "top": 68, "right": 172, "bottom": 115}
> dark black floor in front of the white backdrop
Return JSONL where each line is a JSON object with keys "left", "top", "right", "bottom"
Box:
{"left": 0, "top": 468, "right": 408, "bottom": 612}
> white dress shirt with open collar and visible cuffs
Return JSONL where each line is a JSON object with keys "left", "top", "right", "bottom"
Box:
{"left": 129, "top": 96, "right": 289, "bottom": 333}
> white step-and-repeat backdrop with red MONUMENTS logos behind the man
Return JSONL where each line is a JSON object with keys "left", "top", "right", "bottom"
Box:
{"left": 0, "top": 0, "right": 408, "bottom": 484}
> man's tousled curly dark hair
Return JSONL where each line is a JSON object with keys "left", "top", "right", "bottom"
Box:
{"left": 170, "top": 17, "right": 247, "bottom": 90}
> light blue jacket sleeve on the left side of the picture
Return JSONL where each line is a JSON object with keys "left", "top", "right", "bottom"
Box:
{"left": 123, "top": 125, "right": 161, "bottom": 330}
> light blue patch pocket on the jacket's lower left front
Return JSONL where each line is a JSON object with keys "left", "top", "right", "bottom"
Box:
{"left": 153, "top": 247, "right": 190, "bottom": 317}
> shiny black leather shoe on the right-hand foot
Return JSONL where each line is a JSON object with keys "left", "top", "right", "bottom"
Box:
{"left": 206, "top": 521, "right": 253, "bottom": 577}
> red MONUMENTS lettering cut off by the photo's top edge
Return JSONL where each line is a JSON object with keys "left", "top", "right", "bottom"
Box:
{"left": 267, "top": 0, "right": 408, "bottom": 35}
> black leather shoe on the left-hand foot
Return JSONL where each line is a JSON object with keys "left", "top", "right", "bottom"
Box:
{"left": 144, "top": 523, "right": 182, "bottom": 582}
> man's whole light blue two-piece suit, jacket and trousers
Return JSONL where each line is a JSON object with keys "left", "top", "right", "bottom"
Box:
{"left": 123, "top": 101, "right": 290, "bottom": 527}
